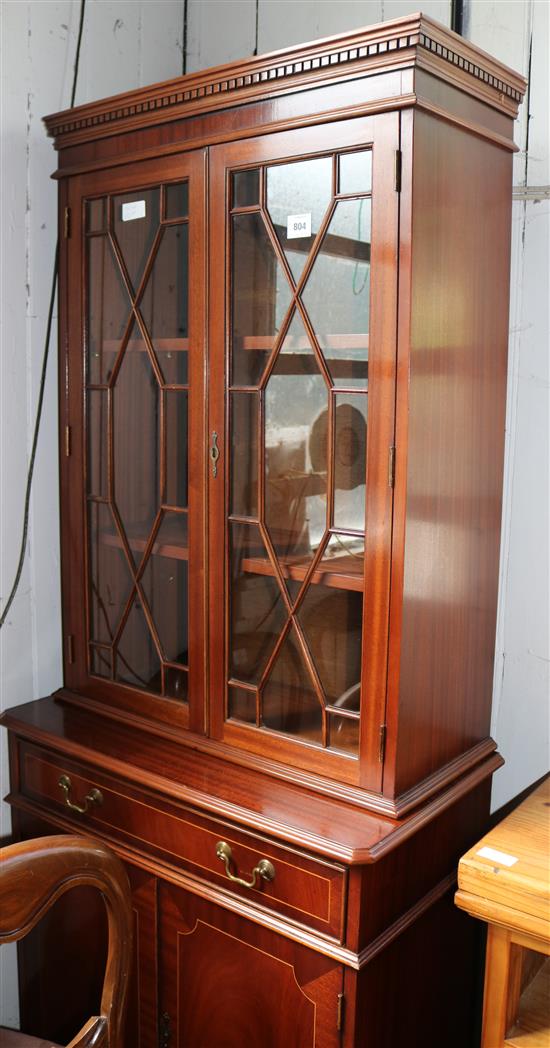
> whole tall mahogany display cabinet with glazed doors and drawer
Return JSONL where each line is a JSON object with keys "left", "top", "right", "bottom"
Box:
{"left": 4, "top": 15, "right": 526, "bottom": 1048}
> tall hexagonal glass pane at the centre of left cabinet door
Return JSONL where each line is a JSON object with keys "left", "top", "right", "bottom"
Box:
{"left": 113, "top": 324, "right": 160, "bottom": 564}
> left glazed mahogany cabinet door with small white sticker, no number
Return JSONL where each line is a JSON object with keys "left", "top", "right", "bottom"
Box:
{"left": 61, "top": 152, "right": 205, "bottom": 732}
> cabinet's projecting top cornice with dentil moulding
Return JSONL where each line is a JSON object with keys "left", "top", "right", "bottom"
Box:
{"left": 45, "top": 14, "right": 527, "bottom": 149}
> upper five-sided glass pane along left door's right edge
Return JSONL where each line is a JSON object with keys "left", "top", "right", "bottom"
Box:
{"left": 139, "top": 224, "right": 189, "bottom": 386}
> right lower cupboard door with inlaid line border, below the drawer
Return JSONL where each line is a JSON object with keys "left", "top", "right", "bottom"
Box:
{"left": 158, "top": 883, "right": 343, "bottom": 1048}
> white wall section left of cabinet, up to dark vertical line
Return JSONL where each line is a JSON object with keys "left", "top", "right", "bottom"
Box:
{"left": 0, "top": 0, "right": 184, "bottom": 1025}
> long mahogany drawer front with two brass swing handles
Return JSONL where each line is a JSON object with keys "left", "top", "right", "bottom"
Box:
{"left": 20, "top": 744, "right": 347, "bottom": 941}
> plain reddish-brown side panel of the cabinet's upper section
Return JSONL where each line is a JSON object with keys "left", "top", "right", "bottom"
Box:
{"left": 395, "top": 113, "right": 512, "bottom": 793}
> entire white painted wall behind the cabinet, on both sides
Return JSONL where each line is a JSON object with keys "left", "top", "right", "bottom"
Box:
{"left": 0, "top": 0, "right": 550, "bottom": 1025}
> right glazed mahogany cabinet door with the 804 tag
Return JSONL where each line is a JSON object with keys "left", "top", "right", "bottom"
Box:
{"left": 210, "top": 113, "right": 399, "bottom": 789}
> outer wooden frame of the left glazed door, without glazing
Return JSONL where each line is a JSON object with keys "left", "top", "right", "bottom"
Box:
{"left": 59, "top": 150, "right": 206, "bottom": 734}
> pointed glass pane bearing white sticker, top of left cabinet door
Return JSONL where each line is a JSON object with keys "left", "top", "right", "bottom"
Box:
{"left": 113, "top": 187, "right": 160, "bottom": 291}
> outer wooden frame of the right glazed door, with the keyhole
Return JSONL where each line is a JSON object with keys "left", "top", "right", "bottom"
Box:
{"left": 208, "top": 112, "right": 399, "bottom": 791}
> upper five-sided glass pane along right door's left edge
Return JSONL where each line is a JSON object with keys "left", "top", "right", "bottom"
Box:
{"left": 232, "top": 214, "right": 291, "bottom": 386}
